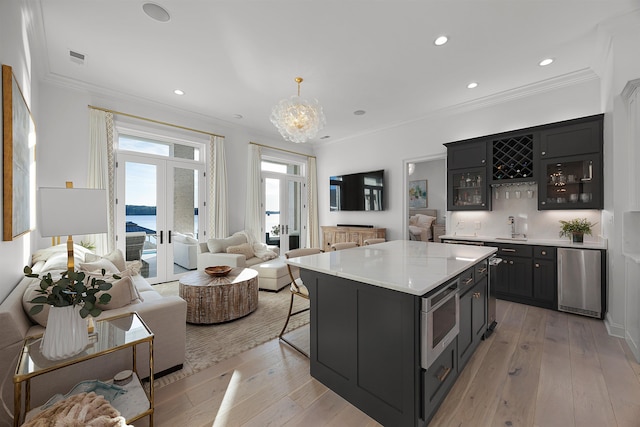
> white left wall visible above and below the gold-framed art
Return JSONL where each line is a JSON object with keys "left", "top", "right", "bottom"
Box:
{"left": 0, "top": 0, "right": 39, "bottom": 301}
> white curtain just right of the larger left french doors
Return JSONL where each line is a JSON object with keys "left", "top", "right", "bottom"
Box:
{"left": 207, "top": 136, "right": 229, "bottom": 239}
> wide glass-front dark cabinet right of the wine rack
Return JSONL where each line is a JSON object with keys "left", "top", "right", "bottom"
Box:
{"left": 538, "top": 154, "right": 604, "bottom": 210}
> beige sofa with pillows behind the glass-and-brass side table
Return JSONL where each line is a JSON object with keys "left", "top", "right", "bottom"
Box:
{"left": 0, "top": 244, "right": 187, "bottom": 426}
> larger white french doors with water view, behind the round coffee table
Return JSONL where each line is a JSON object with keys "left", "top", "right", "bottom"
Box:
{"left": 116, "top": 153, "right": 204, "bottom": 284}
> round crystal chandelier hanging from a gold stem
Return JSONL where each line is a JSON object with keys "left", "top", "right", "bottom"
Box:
{"left": 271, "top": 77, "right": 326, "bottom": 142}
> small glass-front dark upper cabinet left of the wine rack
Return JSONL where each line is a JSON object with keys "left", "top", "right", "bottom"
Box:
{"left": 447, "top": 168, "right": 491, "bottom": 211}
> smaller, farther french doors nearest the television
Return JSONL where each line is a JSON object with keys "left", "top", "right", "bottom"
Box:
{"left": 262, "top": 172, "right": 306, "bottom": 255}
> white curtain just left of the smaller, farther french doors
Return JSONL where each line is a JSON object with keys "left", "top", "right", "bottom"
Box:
{"left": 244, "top": 144, "right": 264, "bottom": 241}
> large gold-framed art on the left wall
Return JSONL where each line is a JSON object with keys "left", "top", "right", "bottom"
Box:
{"left": 2, "top": 65, "right": 35, "bottom": 241}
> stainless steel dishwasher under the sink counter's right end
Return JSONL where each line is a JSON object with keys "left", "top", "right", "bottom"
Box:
{"left": 558, "top": 248, "right": 602, "bottom": 318}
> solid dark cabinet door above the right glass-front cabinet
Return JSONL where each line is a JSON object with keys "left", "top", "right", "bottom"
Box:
{"left": 540, "top": 114, "right": 604, "bottom": 159}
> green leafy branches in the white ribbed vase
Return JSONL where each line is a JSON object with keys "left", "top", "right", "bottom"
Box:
{"left": 24, "top": 266, "right": 115, "bottom": 318}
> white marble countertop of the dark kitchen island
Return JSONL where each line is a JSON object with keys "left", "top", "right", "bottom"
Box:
{"left": 286, "top": 240, "right": 496, "bottom": 296}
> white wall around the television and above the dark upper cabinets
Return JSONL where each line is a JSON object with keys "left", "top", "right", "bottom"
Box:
{"left": 316, "top": 74, "right": 601, "bottom": 240}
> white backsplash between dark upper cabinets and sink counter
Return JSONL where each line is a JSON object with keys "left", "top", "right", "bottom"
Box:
{"left": 447, "top": 184, "right": 602, "bottom": 240}
